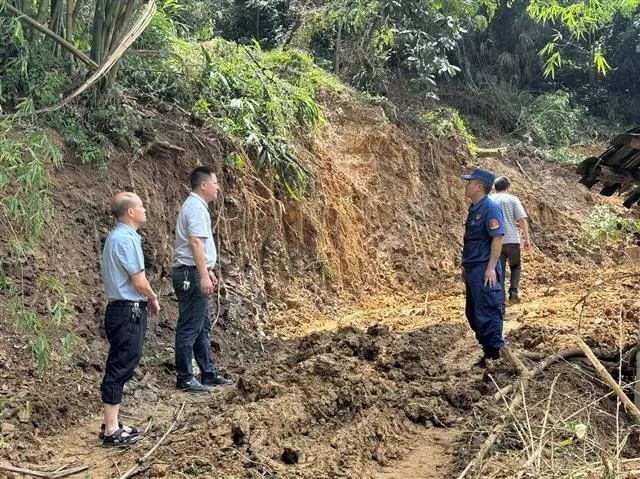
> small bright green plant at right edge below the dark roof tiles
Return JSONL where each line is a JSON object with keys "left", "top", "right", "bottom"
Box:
{"left": 581, "top": 205, "right": 640, "bottom": 244}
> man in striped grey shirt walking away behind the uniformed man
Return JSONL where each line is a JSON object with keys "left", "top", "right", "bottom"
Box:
{"left": 491, "top": 176, "right": 531, "bottom": 311}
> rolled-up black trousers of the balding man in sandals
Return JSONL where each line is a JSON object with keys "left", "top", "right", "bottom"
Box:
{"left": 100, "top": 302, "right": 147, "bottom": 405}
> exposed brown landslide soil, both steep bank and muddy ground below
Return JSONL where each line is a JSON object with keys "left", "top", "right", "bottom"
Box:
{"left": 0, "top": 97, "right": 640, "bottom": 478}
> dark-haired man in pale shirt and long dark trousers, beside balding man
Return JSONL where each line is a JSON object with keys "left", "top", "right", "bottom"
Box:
{"left": 172, "top": 166, "right": 232, "bottom": 393}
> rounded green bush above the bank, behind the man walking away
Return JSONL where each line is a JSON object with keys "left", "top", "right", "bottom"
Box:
{"left": 518, "top": 91, "right": 584, "bottom": 146}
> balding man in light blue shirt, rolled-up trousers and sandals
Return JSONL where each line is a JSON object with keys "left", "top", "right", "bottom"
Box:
{"left": 100, "top": 192, "right": 160, "bottom": 447}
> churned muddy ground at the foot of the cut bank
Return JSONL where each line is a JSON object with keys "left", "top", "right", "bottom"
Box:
{"left": 1, "top": 261, "right": 640, "bottom": 478}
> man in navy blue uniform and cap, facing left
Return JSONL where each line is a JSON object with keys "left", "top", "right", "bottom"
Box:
{"left": 462, "top": 168, "right": 504, "bottom": 368}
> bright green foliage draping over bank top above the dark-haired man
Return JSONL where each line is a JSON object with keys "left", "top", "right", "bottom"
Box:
{"left": 122, "top": 36, "right": 336, "bottom": 198}
